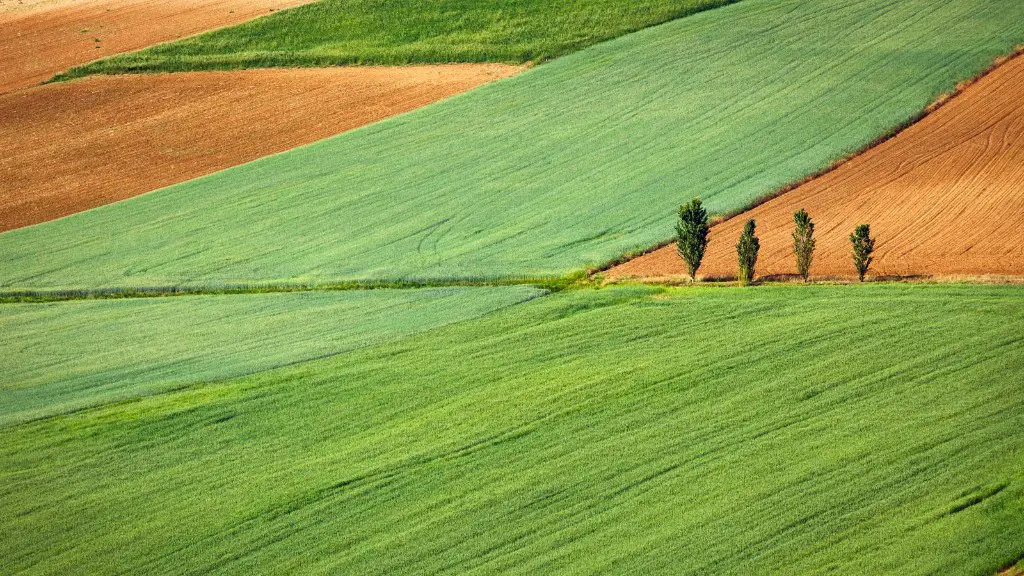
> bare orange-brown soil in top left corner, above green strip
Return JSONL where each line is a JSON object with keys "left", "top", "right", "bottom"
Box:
{"left": 0, "top": 0, "right": 311, "bottom": 93}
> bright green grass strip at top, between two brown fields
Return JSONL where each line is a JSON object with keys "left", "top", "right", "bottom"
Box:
{"left": 56, "top": 0, "right": 736, "bottom": 80}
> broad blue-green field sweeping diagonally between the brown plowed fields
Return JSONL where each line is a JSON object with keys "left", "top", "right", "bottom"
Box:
{"left": 0, "top": 0, "right": 1024, "bottom": 291}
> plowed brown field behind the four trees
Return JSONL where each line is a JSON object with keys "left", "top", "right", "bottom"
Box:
{"left": 607, "top": 56, "right": 1024, "bottom": 279}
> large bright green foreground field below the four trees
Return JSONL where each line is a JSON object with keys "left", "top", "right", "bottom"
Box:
{"left": 0, "top": 285, "right": 1024, "bottom": 576}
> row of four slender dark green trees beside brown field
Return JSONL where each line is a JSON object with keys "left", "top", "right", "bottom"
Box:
{"left": 676, "top": 198, "right": 874, "bottom": 285}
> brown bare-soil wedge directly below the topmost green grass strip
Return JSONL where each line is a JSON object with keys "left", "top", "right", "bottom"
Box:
{"left": 0, "top": 65, "right": 521, "bottom": 231}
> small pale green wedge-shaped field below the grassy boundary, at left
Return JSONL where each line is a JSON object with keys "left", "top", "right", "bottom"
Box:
{"left": 0, "top": 286, "right": 544, "bottom": 425}
